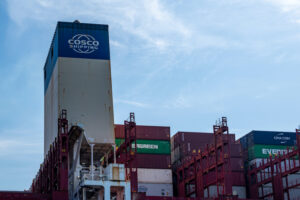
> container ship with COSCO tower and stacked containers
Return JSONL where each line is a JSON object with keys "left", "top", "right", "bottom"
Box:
{"left": 0, "top": 21, "right": 300, "bottom": 200}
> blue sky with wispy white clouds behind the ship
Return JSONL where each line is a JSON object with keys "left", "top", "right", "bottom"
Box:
{"left": 0, "top": 0, "right": 300, "bottom": 190}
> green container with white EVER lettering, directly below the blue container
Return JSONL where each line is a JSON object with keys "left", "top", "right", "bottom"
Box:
{"left": 248, "top": 144, "right": 297, "bottom": 160}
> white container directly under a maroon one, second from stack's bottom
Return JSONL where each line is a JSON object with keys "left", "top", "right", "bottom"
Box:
{"left": 137, "top": 168, "right": 172, "bottom": 184}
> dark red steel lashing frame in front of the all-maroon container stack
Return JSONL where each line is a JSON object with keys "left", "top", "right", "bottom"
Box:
{"left": 177, "top": 117, "right": 234, "bottom": 198}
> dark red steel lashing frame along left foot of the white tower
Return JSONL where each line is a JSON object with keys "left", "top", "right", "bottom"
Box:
{"left": 30, "top": 110, "right": 69, "bottom": 199}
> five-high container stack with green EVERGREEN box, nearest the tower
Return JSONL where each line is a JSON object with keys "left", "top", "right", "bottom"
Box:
{"left": 115, "top": 124, "right": 173, "bottom": 196}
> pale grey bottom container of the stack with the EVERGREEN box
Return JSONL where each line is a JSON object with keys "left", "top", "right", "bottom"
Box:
{"left": 138, "top": 183, "right": 173, "bottom": 197}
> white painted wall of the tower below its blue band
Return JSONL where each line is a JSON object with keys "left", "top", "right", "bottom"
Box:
{"left": 44, "top": 57, "right": 115, "bottom": 155}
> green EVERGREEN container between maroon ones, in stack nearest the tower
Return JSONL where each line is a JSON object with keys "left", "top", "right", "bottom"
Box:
{"left": 115, "top": 139, "right": 171, "bottom": 154}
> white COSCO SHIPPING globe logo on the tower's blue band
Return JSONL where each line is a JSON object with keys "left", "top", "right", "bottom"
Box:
{"left": 68, "top": 34, "right": 99, "bottom": 54}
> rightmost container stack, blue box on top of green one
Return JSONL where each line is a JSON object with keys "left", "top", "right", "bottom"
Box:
{"left": 240, "top": 130, "right": 300, "bottom": 197}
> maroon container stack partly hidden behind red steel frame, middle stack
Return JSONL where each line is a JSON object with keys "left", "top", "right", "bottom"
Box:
{"left": 171, "top": 132, "right": 246, "bottom": 198}
